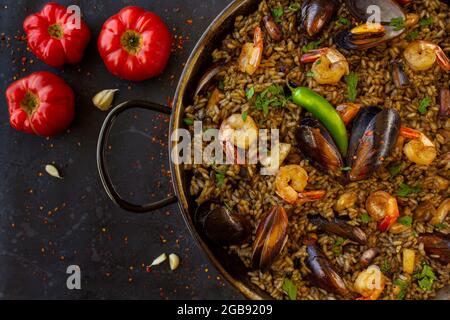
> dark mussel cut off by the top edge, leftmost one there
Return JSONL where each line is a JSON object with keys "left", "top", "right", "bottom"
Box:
{"left": 301, "top": 0, "right": 338, "bottom": 37}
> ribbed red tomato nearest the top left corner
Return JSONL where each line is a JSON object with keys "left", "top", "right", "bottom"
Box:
{"left": 23, "top": 3, "right": 91, "bottom": 67}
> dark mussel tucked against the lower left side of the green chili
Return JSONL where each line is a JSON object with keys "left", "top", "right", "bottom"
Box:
{"left": 296, "top": 117, "right": 344, "bottom": 172}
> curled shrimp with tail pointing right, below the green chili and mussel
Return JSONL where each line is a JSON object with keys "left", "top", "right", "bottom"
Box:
{"left": 275, "top": 165, "right": 326, "bottom": 205}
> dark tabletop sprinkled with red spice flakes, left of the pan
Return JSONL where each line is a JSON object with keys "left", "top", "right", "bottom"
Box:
{"left": 0, "top": 0, "right": 246, "bottom": 299}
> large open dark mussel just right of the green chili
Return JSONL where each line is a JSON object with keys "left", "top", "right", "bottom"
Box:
{"left": 347, "top": 108, "right": 400, "bottom": 181}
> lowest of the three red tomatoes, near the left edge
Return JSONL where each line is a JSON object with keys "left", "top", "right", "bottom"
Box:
{"left": 6, "top": 72, "right": 75, "bottom": 137}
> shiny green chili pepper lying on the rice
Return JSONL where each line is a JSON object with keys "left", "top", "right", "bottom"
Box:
{"left": 292, "top": 87, "right": 348, "bottom": 156}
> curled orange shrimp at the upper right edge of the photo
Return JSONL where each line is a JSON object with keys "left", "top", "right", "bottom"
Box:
{"left": 403, "top": 40, "right": 450, "bottom": 71}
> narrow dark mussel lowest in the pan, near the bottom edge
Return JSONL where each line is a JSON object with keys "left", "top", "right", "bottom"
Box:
{"left": 306, "top": 244, "right": 351, "bottom": 298}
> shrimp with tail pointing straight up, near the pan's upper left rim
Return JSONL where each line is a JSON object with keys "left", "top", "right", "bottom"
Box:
{"left": 238, "top": 27, "right": 264, "bottom": 75}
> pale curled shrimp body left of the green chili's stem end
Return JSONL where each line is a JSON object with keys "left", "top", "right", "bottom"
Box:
{"left": 219, "top": 113, "right": 258, "bottom": 149}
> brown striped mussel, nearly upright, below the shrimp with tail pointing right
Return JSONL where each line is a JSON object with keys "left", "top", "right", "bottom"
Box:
{"left": 252, "top": 206, "right": 288, "bottom": 272}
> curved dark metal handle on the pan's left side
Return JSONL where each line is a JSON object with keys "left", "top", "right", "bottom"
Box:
{"left": 97, "top": 100, "right": 178, "bottom": 213}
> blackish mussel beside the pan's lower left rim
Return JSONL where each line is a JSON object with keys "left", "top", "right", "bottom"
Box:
{"left": 194, "top": 202, "right": 251, "bottom": 246}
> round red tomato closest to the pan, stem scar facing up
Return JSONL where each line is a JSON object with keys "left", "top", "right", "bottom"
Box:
{"left": 98, "top": 7, "right": 172, "bottom": 81}
